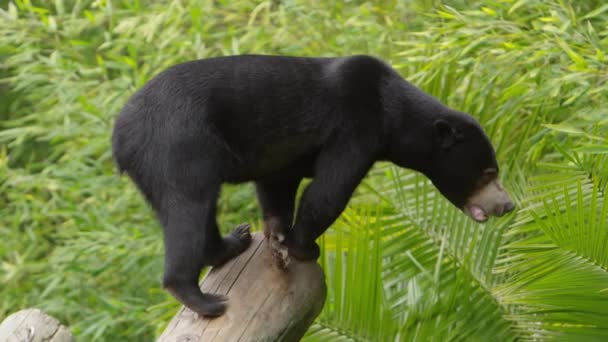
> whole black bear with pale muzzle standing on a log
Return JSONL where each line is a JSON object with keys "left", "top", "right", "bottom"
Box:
{"left": 112, "top": 55, "right": 514, "bottom": 316}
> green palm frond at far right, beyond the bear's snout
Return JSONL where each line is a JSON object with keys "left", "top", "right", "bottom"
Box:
{"left": 496, "top": 146, "right": 608, "bottom": 341}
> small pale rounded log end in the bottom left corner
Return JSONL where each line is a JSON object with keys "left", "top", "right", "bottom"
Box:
{"left": 0, "top": 309, "right": 74, "bottom": 342}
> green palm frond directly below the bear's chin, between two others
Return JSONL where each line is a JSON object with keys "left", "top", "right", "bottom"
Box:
{"left": 385, "top": 168, "right": 515, "bottom": 340}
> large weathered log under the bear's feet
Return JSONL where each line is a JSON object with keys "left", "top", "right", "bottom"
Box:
{"left": 159, "top": 233, "right": 327, "bottom": 342}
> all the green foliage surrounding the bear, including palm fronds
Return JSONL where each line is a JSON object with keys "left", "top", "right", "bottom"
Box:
{"left": 0, "top": 0, "right": 608, "bottom": 341}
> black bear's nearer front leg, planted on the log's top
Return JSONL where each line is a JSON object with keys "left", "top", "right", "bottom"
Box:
{"left": 285, "top": 144, "right": 374, "bottom": 260}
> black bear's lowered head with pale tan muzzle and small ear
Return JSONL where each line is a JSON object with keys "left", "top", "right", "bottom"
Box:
{"left": 427, "top": 111, "right": 514, "bottom": 222}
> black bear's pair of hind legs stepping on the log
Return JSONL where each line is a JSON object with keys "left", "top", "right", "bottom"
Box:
{"left": 161, "top": 184, "right": 251, "bottom": 316}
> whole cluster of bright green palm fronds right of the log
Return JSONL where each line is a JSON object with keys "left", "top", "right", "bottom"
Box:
{"left": 309, "top": 148, "right": 608, "bottom": 341}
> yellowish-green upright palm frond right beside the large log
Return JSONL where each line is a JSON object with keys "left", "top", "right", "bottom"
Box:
{"left": 308, "top": 204, "right": 397, "bottom": 340}
